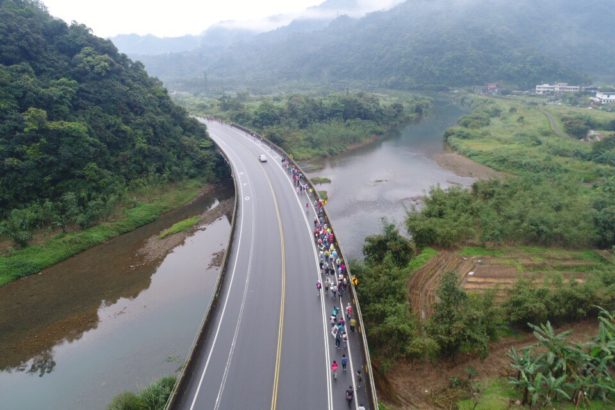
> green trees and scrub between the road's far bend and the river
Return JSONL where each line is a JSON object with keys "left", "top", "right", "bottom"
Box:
{"left": 178, "top": 92, "right": 430, "bottom": 160}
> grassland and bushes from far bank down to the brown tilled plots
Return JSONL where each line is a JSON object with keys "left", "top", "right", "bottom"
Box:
{"left": 406, "top": 97, "right": 615, "bottom": 249}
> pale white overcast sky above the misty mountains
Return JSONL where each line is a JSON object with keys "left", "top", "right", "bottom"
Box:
{"left": 43, "top": 0, "right": 398, "bottom": 37}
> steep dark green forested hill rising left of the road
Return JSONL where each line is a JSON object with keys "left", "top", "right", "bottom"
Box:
{"left": 0, "top": 0, "right": 219, "bottom": 243}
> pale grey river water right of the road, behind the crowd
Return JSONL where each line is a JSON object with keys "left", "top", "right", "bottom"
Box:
{"left": 307, "top": 100, "right": 474, "bottom": 258}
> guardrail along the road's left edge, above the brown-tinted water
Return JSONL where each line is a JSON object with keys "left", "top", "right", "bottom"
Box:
{"left": 165, "top": 140, "right": 239, "bottom": 410}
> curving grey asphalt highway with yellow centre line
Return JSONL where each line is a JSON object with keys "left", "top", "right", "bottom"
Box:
{"left": 175, "top": 121, "right": 361, "bottom": 410}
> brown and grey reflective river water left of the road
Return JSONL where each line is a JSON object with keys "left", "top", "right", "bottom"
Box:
{"left": 0, "top": 187, "right": 231, "bottom": 410}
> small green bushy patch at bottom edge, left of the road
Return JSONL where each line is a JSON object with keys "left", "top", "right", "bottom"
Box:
{"left": 107, "top": 376, "right": 176, "bottom": 410}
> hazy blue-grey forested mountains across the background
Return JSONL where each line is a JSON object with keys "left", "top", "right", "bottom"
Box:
{"left": 142, "top": 0, "right": 615, "bottom": 89}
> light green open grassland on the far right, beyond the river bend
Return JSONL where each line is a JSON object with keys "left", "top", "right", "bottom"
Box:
{"left": 448, "top": 97, "right": 615, "bottom": 183}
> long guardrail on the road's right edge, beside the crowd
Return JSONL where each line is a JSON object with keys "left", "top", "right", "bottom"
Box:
{"left": 231, "top": 120, "right": 378, "bottom": 410}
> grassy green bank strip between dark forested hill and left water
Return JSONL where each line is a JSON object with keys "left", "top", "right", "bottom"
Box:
{"left": 0, "top": 179, "right": 203, "bottom": 286}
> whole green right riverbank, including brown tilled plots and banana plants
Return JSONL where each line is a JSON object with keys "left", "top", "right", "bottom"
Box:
{"left": 352, "top": 97, "right": 615, "bottom": 408}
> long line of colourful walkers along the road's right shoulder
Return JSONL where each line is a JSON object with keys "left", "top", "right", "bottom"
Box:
{"left": 282, "top": 159, "right": 363, "bottom": 406}
